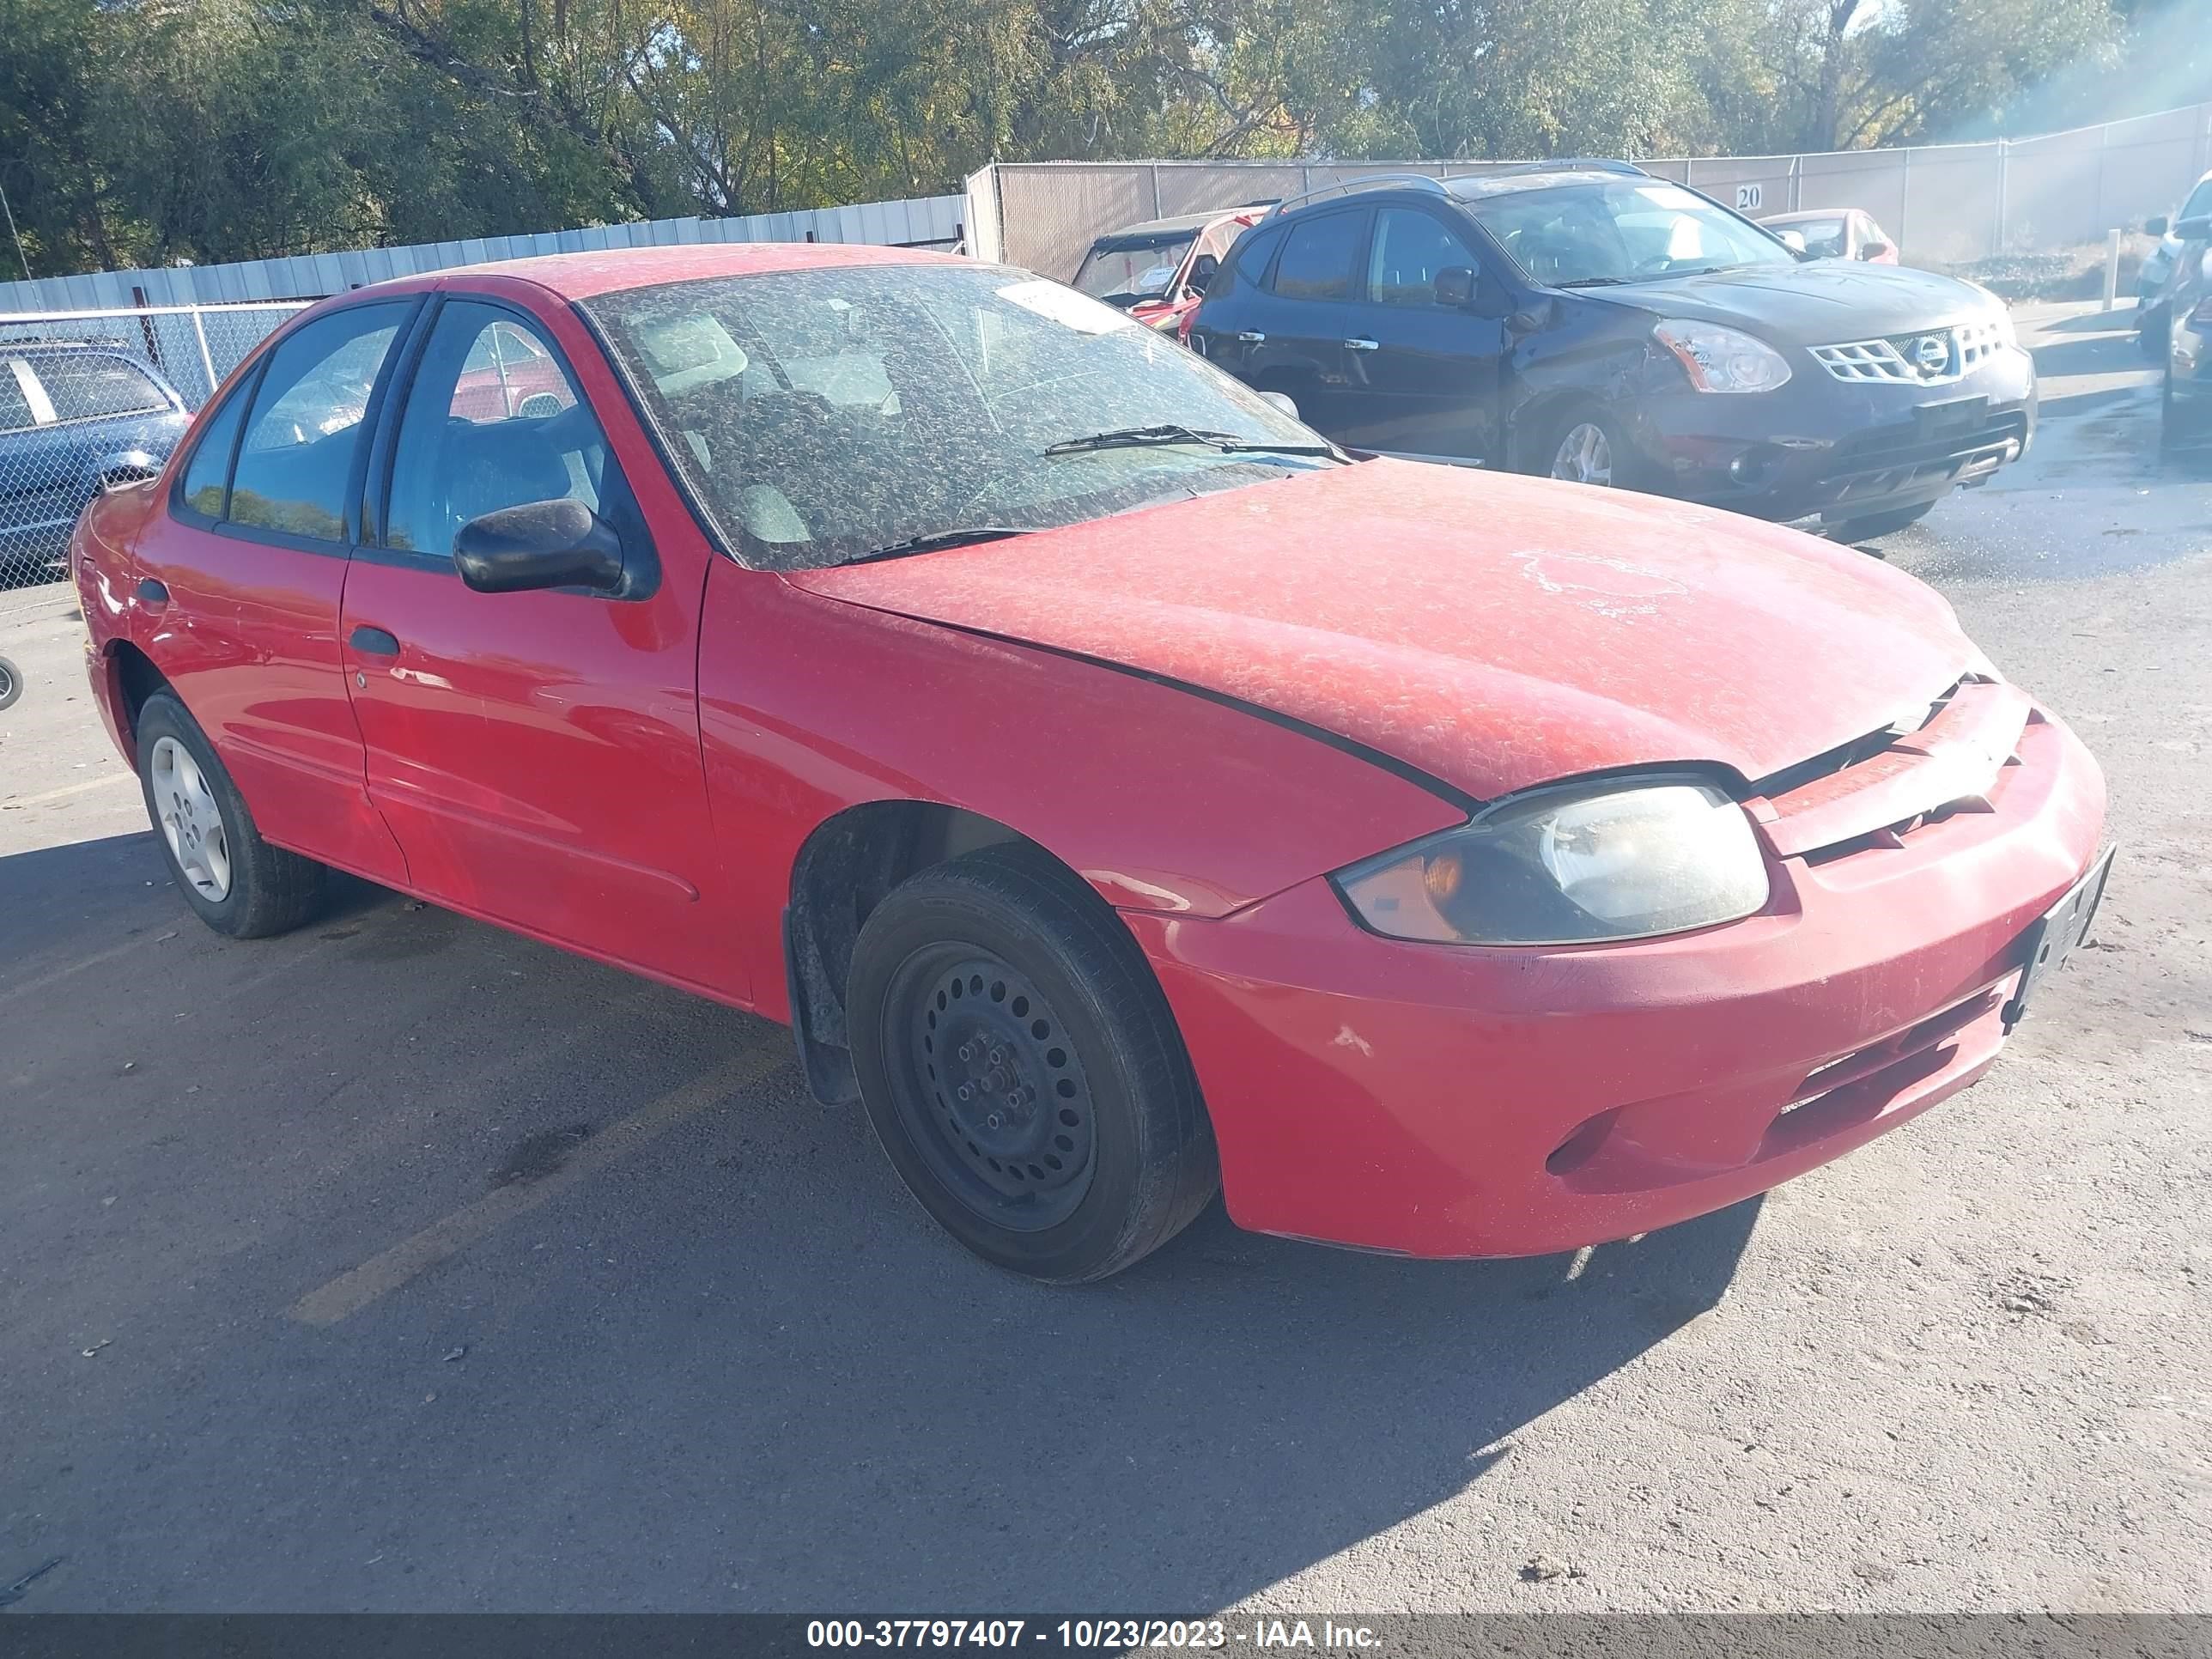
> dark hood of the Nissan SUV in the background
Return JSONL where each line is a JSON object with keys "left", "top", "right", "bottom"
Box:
{"left": 1575, "top": 258, "right": 1996, "bottom": 345}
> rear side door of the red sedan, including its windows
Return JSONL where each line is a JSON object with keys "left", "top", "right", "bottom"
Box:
{"left": 133, "top": 299, "right": 416, "bottom": 883}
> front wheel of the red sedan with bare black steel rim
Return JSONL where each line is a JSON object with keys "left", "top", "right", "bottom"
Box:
{"left": 845, "top": 845, "right": 1221, "bottom": 1285}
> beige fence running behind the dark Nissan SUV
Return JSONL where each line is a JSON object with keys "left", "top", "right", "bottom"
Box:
{"left": 964, "top": 104, "right": 2212, "bottom": 279}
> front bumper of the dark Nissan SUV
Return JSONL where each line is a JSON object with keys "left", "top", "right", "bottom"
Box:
{"left": 1628, "top": 347, "right": 2035, "bottom": 520}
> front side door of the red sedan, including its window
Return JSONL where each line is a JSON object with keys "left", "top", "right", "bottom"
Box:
{"left": 341, "top": 296, "right": 745, "bottom": 994}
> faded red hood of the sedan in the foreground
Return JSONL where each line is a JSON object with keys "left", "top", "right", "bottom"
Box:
{"left": 787, "top": 460, "right": 1975, "bottom": 799}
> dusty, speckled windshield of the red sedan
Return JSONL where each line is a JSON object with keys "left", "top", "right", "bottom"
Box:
{"left": 588, "top": 264, "right": 1340, "bottom": 571}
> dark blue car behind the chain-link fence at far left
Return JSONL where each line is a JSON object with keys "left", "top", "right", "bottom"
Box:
{"left": 0, "top": 338, "right": 192, "bottom": 588}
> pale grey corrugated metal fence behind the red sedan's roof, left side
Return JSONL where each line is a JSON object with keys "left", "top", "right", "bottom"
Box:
{"left": 0, "top": 197, "right": 967, "bottom": 312}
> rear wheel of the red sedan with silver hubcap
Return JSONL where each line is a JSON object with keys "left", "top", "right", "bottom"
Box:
{"left": 137, "top": 692, "right": 330, "bottom": 938}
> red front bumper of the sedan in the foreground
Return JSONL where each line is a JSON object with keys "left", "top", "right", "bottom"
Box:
{"left": 1128, "top": 703, "right": 2104, "bottom": 1256}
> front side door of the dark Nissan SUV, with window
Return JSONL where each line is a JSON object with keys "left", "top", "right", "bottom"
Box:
{"left": 1332, "top": 208, "right": 1506, "bottom": 462}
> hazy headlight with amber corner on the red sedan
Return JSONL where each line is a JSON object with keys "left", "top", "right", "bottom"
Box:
{"left": 1336, "top": 781, "right": 1767, "bottom": 945}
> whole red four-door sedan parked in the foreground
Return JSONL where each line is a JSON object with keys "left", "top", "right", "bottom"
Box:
{"left": 73, "top": 246, "right": 2108, "bottom": 1281}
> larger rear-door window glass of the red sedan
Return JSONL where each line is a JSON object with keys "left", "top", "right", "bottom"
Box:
{"left": 230, "top": 303, "right": 407, "bottom": 542}
